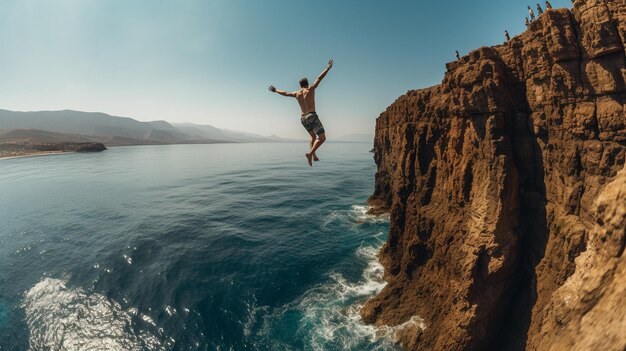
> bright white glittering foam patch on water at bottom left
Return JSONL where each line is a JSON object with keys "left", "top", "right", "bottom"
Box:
{"left": 22, "top": 278, "right": 169, "bottom": 351}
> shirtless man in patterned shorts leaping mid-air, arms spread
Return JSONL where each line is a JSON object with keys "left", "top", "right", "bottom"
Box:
{"left": 268, "top": 60, "right": 333, "bottom": 166}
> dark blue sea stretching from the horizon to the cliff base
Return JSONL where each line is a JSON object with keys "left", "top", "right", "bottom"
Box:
{"left": 0, "top": 143, "right": 397, "bottom": 350}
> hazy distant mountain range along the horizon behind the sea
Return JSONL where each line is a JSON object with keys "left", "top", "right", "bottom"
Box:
{"left": 0, "top": 109, "right": 300, "bottom": 146}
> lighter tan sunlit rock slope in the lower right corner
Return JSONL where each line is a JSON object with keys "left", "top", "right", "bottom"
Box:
{"left": 529, "top": 168, "right": 626, "bottom": 351}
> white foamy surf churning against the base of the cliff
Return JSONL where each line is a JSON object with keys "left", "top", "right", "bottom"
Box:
{"left": 279, "top": 205, "right": 397, "bottom": 350}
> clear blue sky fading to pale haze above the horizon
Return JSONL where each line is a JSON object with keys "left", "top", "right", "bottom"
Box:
{"left": 0, "top": 0, "right": 570, "bottom": 137}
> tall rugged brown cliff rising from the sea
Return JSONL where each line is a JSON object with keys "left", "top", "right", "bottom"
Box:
{"left": 361, "top": 0, "right": 626, "bottom": 350}
